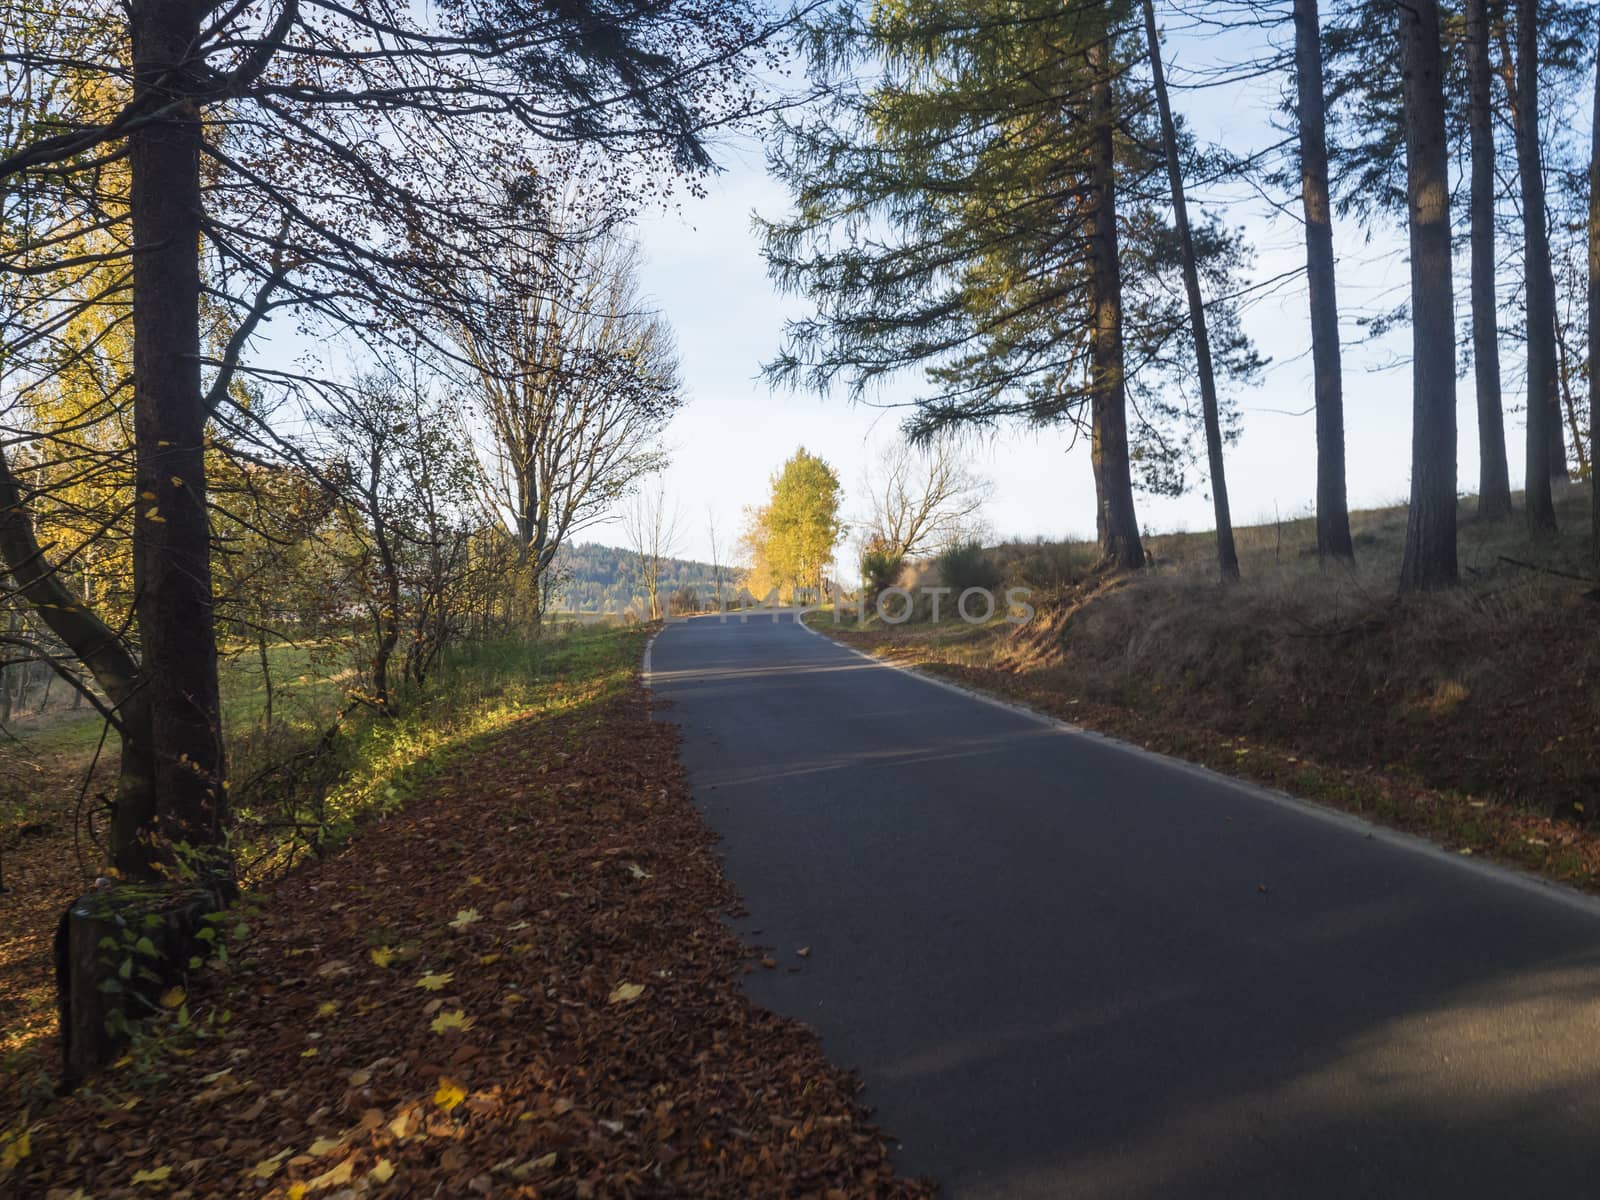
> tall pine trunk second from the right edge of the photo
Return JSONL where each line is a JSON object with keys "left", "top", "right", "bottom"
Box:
{"left": 1512, "top": 0, "right": 1566, "bottom": 538}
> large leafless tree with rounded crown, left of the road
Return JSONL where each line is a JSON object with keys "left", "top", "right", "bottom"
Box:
{"left": 456, "top": 219, "right": 683, "bottom": 622}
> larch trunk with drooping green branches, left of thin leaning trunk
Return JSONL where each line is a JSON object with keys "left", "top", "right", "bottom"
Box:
{"left": 1090, "top": 42, "right": 1144, "bottom": 568}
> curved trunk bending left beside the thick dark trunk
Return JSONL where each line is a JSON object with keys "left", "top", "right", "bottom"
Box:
{"left": 0, "top": 448, "right": 155, "bottom": 880}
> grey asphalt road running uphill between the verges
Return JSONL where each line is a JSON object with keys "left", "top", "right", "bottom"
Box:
{"left": 651, "top": 616, "right": 1600, "bottom": 1200}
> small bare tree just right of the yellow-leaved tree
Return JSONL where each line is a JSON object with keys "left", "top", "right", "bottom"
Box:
{"left": 864, "top": 434, "right": 994, "bottom": 560}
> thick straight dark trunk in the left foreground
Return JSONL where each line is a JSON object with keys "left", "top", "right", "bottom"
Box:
{"left": 128, "top": 0, "right": 227, "bottom": 875}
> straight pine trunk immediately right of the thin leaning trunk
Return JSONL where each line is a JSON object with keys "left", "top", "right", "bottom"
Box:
{"left": 1294, "top": 0, "right": 1355, "bottom": 558}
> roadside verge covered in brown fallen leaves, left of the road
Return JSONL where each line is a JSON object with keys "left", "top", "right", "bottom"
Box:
{"left": 0, "top": 630, "right": 928, "bottom": 1200}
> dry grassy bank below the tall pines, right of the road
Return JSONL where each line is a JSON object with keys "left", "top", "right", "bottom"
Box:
{"left": 808, "top": 485, "right": 1600, "bottom": 891}
